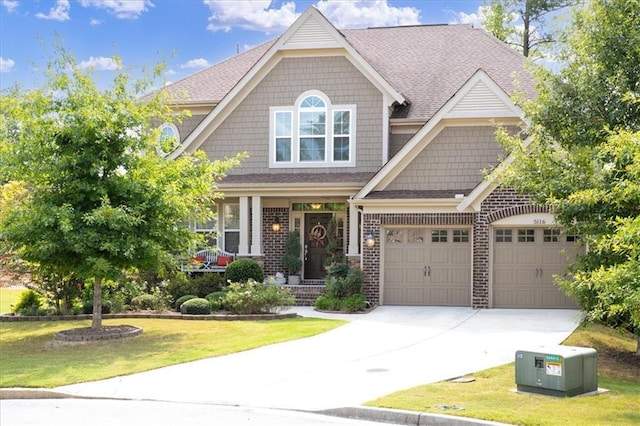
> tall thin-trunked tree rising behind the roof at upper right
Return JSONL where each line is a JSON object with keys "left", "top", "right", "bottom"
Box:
{"left": 482, "top": 0, "right": 577, "bottom": 57}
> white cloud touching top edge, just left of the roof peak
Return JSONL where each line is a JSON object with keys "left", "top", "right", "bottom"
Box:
{"left": 204, "top": 0, "right": 300, "bottom": 33}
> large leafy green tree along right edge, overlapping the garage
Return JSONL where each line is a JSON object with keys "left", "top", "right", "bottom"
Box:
{"left": 503, "top": 0, "right": 640, "bottom": 350}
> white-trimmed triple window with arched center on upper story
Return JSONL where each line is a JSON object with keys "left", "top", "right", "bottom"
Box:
{"left": 269, "top": 90, "right": 356, "bottom": 167}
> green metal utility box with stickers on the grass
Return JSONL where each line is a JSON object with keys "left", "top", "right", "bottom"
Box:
{"left": 516, "top": 346, "right": 598, "bottom": 396}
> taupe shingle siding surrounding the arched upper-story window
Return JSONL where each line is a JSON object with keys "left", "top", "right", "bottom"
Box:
{"left": 201, "top": 57, "right": 382, "bottom": 174}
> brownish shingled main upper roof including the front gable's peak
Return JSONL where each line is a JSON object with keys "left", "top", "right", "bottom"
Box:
{"left": 166, "top": 7, "right": 534, "bottom": 121}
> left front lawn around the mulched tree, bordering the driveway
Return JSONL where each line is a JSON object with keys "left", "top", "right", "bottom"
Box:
{"left": 0, "top": 318, "right": 345, "bottom": 387}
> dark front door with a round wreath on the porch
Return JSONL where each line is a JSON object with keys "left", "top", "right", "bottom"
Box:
{"left": 304, "top": 213, "right": 333, "bottom": 280}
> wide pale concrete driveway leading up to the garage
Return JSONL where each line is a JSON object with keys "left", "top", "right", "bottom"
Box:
{"left": 56, "top": 306, "right": 580, "bottom": 411}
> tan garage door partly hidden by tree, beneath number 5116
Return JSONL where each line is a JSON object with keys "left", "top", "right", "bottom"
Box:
{"left": 492, "top": 228, "right": 582, "bottom": 308}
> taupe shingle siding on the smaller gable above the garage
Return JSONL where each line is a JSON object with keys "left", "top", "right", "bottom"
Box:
{"left": 385, "top": 126, "right": 505, "bottom": 191}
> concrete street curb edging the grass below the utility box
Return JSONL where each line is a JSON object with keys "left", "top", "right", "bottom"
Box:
{"left": 315, "top": 407, "right": 508, "bottom": 426}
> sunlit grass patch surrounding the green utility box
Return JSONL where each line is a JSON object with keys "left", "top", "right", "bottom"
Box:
{"left": 367, "top": 324, "right": 640, "bottom": 426}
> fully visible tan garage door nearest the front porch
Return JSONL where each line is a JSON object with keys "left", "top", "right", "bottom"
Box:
{"left": 383, "top": 228, "right": 471, "bottom": 306}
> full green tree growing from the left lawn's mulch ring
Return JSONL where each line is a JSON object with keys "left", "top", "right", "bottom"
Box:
{"left": 0, "top": 49, "right": 239, "bottom": 331}
